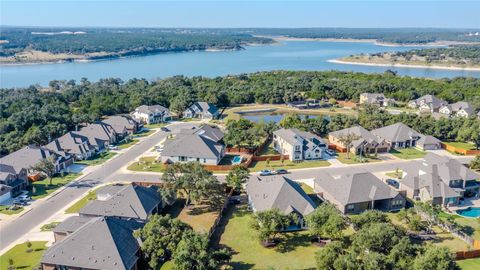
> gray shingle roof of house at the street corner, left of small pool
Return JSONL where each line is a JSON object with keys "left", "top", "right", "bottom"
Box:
{"left": 162, "top": 130, "right": 223, "bottom": 159}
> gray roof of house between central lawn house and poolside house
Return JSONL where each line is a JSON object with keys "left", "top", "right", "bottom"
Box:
{"left": 314, "top": 172, "right": 399, "bottom": 206}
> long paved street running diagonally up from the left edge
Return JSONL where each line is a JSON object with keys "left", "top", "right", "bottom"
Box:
{"left": 0, "top": 122, "right": 195, "bottom": 250}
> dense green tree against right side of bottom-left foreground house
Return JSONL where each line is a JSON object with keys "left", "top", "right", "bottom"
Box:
{"left": 134, "top": 215, "right": 192, "bottom": 269}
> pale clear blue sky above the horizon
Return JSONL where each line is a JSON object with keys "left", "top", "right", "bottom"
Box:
{"left": 0, "top": 0, "right": 480, "bottom": 28}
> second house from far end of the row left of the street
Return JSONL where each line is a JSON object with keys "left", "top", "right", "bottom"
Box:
{"left": 76, "top": 122, "right": 117, "bottom": 152}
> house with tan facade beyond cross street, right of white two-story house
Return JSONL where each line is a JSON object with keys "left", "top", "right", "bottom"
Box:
{"left": 328, "top": 126, "right": 389, "bottom": 154}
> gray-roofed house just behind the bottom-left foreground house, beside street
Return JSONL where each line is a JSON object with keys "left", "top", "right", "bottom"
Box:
{"left": 79, "top": 184, "right": 164, "bottom": 222}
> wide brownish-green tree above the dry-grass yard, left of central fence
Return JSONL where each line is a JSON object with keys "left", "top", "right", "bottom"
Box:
{"left": 162, "top": 162, "right": 219, "bottom": 206}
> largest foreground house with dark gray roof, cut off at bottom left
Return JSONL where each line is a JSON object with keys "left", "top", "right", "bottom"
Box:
{"left": 41, "top": 217, "right": 143, "bottom": 270}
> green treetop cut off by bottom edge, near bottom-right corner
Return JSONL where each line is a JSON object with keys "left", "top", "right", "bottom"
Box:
{"left": 413, "top": 245, "right": 460, "bottom": 270}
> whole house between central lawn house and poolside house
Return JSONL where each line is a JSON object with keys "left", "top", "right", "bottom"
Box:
{"left": 314, "top": 172, "right": 405, "bottom": 214}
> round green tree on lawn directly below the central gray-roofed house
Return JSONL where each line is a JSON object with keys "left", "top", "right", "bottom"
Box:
{"left": 252, "top": 208, "right": 292, "bottom": 243}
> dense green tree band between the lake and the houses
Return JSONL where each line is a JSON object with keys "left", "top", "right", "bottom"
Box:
{"left": 0, "top": 71, "right": 480, "bottom": 155}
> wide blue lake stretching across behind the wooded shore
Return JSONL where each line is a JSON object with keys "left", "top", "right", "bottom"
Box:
{"left": 0, "top": 41, "right": 480, "bottom": 87}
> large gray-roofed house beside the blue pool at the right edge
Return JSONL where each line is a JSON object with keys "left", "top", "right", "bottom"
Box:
{"left": 400, "top": 153, "right": 480, "bottom": 206}
